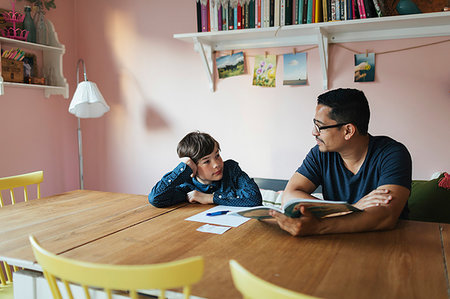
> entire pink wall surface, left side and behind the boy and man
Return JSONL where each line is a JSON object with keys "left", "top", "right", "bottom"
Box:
{"left": 0, "top": 0, "right": 450, "bottom": 202}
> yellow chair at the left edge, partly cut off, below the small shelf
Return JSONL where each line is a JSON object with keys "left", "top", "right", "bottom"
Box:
{"left": 0, "top": 171, "right": 44, "bottom": 298}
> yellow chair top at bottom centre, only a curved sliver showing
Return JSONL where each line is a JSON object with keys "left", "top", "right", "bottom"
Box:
{"left": 230, "top": 260, "right": 317, "bottom": 299}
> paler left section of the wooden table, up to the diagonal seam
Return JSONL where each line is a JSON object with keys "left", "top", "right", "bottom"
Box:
{"left": 0, "top": 190, "right": 184, "bottom": 269}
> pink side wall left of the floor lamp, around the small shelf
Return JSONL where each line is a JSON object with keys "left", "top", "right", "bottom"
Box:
{"left": 0, "top": 0, "right": 78, "bottom": 202}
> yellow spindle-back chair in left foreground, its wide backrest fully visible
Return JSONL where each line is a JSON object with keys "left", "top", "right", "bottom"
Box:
{"left": 29, "top": 236, "right": 204, "bottom": 299}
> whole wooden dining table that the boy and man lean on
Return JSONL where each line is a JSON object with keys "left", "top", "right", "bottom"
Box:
{"left": 0, "top": 191, "right": 450, "bottom": 298}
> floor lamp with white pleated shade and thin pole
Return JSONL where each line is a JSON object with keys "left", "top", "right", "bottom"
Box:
{"left": 69, "top": 59, "right": 109, "bottom": 190}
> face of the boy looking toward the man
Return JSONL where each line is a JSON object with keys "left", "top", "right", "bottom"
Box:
{"left": 197, "top": 144, "right": 223, "bottom": 184}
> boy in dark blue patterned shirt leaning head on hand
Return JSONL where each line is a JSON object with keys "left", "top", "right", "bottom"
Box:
{"left": 148, "top": 132, "right": 262, "bottom": 208}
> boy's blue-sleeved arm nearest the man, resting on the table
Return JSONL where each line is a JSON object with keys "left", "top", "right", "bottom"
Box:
{"left": 213, "top": 160, "right": 262, "bottom": 207}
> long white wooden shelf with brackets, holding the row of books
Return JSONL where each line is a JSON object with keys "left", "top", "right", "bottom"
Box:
{"left": 173, "top": 12, "right": 450, "bottom": 91}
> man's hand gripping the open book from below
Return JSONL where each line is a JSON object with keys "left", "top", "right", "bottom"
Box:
{"left": 270, "top": 205, "right": 321, "bottom": 236}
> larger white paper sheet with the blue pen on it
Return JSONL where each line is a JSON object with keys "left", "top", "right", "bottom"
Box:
{"left": 185, "top": 206, "right": 250, "bottom": 227}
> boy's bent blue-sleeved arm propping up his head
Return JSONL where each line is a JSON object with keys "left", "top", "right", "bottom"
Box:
{"left": 148, "top": 162, "right": 192, "bottom": 208}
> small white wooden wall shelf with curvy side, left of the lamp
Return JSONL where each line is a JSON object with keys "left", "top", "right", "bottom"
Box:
{"left": 0, "top": 20, "right": 69, "bottom": 99}
